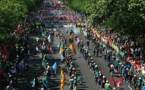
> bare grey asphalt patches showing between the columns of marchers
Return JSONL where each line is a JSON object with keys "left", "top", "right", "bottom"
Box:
{"left": 14, "top": 0, "right": 134, "bottom": 90}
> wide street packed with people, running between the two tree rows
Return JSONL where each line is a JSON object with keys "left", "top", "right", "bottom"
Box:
{"left": 0, "top": 0, "right": 144, "bottom": 90}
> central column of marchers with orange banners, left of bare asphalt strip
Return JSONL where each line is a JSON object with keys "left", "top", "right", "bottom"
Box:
{"left": 55, "top": 27, "right": 82, "bottom": 90}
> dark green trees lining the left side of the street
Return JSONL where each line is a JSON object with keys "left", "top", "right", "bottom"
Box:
{"left": 0, "top": 0, "right": 42, "bottom": 40}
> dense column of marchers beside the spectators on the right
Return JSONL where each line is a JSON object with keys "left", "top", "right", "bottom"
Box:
{"left": 82, "top": 28, "right": 144, "bottom": 90}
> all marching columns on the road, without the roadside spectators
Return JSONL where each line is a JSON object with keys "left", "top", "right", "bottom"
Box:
{"left": 1, "top": 14, "right": 144, "bottom": 90}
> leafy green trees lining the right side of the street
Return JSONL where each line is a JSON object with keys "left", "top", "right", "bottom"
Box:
{"left": 68, "top": 0, "right": 145, "bottom": 36}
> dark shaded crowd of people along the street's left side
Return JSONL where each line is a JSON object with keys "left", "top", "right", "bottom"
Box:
{"left": 0, "top": 2, "right": 60, "bottom": 90}
